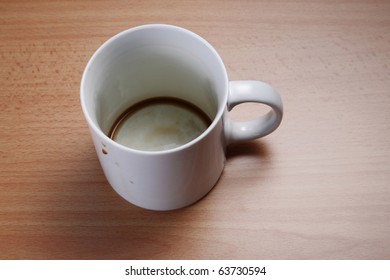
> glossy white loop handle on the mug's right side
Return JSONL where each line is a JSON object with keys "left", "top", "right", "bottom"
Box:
{"left": 225, "top": 81, "right": 283, "bottom": 145}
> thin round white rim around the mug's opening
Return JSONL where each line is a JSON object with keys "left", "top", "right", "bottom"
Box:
{"left": 80, "top": 24, "right": 229, "bottom": 155}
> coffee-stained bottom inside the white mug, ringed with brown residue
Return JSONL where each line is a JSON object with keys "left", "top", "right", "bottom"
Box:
{"left": 108, "top": 97, "right": 212, "bottom": 151}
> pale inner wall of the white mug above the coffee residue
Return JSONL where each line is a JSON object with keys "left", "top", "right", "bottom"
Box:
{"left": 81, "top": 25, "right": 228, "bottom": 142}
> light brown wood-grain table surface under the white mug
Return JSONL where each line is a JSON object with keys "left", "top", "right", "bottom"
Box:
{"left": 0, "top": 0, "right": 390, "bottom": 259}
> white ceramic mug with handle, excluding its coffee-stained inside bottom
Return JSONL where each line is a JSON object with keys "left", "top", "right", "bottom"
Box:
{"left": 80, "top": 24, "right": 283, "bottom": 210}
